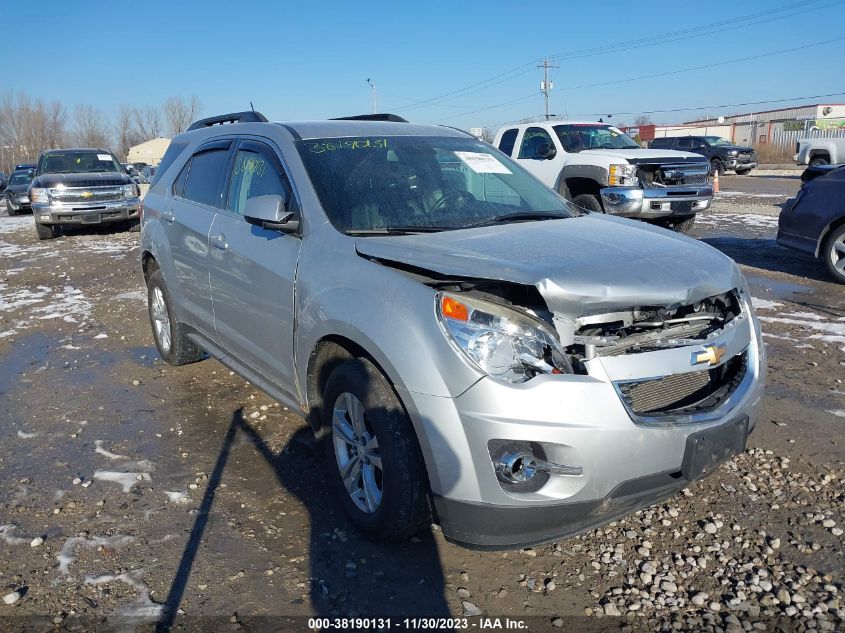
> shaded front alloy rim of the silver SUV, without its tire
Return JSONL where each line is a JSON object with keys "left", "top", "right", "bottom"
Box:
{"left": 332, "top": 392, "right": 384, "bottom": 514}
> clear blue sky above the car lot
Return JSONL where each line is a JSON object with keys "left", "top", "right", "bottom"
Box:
{"left": 6, "top": 0, "right": 845, "bottom": 128}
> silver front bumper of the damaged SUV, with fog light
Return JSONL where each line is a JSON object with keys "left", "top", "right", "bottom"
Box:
{"left": 402, "top": 321, "right": 765, "bottom": 549}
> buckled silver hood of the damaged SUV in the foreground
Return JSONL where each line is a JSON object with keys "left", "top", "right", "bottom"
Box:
{"left": 355, "top": 214, "right": 740, "bottom": 318}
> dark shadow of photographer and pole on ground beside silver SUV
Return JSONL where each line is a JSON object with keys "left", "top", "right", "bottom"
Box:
{"left": 156, "top": 398, "right": 450, "bottom": 632}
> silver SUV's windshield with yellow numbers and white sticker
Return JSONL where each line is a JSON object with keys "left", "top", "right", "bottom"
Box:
{"left": 297, "top": 136, "right": 579, "bottom": 232}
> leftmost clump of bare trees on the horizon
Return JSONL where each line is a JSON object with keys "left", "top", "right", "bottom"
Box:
{"left": 0, "top": 93, "right": 65, "bottom": 170}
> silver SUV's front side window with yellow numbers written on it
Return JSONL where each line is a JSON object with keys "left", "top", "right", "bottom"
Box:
{"left": 226, "top": 143, "right": 290, "bottom": 215}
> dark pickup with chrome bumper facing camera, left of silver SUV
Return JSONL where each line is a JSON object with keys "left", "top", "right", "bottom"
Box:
{"left": 29, "top": 148, "right": 140, "bottom": 240}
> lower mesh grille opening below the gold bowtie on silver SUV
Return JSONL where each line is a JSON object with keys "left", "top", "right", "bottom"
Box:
{"left": 618, "top": 352, "right": 746, "bottom": 415}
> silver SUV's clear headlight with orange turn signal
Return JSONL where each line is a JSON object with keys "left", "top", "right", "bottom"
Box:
{"left": 436, "top": 293, "right": 572, "bottom": 383}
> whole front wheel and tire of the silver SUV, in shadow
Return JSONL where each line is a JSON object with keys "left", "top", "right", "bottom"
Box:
{"left": 322, "top": 358, "right": 431, "bottom": 541}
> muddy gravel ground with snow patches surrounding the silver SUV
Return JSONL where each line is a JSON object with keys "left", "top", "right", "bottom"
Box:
{"left": 0, "top": 175, "right": 845, "bottom": 631}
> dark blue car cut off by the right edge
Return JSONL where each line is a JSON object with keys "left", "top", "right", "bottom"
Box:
{"left": 777, "top": 166, "right": 845, "bottom": 283}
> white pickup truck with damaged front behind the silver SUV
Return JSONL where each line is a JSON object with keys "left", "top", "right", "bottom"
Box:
{"left": 493, "top": 121, "right": 713, "bottom": 233}
